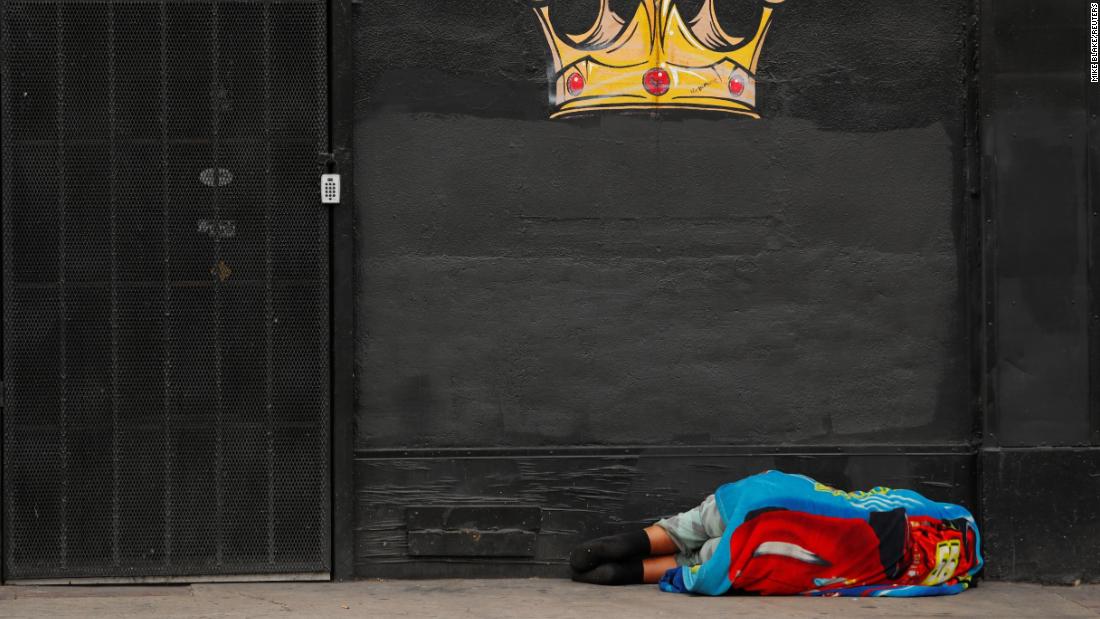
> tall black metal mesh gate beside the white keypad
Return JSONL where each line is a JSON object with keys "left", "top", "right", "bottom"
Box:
{"left": 0, "top": 0, "right": 330, "bottom": 579}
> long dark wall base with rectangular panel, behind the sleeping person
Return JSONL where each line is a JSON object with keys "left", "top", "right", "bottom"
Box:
{"left": 355, "top": 445, "right": 976, "bottom": 578}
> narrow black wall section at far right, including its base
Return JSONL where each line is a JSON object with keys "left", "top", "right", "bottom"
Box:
{"left": 980, "top": 0, "right": 1100, "bottom": 583}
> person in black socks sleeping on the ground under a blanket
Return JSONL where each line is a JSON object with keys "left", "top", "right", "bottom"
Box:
{"left": 570, "top": 471, "right": 982, "bottom": 597}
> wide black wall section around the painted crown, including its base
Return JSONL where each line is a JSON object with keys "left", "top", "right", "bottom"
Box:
{"left": 354, "top": 0, "right": 980, "bottom": 576}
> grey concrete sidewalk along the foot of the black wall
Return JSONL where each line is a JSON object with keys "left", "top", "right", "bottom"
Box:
{"left": 0, "top": 579, "right": 1100, "bottom": 619}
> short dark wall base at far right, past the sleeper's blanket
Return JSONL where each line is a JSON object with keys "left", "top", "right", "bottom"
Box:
{"left": 981, "top": 447, "right": 1100, "bottom": 584}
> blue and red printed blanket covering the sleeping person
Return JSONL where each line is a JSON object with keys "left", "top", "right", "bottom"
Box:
{"left": 660, "top": 471, "right": 982, "bottom": 597}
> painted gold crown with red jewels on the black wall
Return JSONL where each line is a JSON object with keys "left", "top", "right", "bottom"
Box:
{"left": 534, "top": 0, "right": 783, "bottom": 118}
